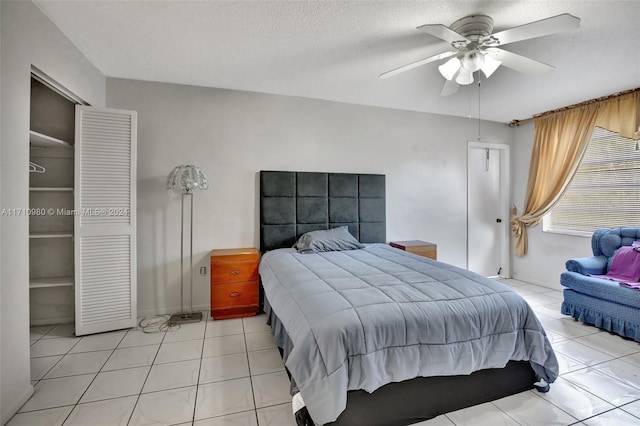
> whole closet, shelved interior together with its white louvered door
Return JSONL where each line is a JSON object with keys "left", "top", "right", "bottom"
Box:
{"left": 29, "top": 75, "right": 137, "bottom": 335}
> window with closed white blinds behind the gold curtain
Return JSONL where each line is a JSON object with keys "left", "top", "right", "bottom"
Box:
{"left": 543, "top": 127, "right": 640, "bottom": 235}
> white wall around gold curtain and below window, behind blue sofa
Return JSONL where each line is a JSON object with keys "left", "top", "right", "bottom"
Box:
{"left": 511, "top": 122, "right": 593, "bottom": 290}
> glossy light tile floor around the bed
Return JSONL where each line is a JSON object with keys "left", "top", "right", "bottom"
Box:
{"left": 8, "top": 280, "right": 640, "bottom": 426}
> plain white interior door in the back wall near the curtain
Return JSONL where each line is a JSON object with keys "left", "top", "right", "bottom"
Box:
{"left": 467, "top": 142, "right": 510, "bottom": 277}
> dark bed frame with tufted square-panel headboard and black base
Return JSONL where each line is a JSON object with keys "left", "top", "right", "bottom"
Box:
{"left": 260, "top": 171, "right": 536, "bottom": 426}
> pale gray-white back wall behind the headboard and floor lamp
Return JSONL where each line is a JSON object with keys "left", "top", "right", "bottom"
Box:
{"left": 107, "top": 78, "right": 512, "bottom": 314}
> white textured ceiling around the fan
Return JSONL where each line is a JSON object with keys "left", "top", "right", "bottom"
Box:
{"left": 36, "top": 0, "right": 640, "bottom": 122}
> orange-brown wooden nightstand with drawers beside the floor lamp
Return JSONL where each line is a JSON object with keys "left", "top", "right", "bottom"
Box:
{"left": 211, "top": 248, "right": 260, "bottom": 319}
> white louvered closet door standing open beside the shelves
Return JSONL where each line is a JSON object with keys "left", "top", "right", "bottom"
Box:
{"left": 74, "top": 106, "right": 137, "bottom": 335}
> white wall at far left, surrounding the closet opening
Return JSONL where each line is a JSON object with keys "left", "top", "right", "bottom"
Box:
{"left": 0, "top": 1, "right": 105, "bottom": 424}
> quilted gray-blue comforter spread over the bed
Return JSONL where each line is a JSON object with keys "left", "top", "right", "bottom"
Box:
{"left": 260, "top": 244, "right": 558, "bottom": 424}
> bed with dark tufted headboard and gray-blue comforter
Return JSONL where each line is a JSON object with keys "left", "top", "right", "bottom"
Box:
{"left": 260, "top": 171, "right": 558, "bottom": 426}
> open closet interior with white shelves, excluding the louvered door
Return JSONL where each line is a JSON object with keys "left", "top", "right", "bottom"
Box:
{"left": 29, "top": 76, "right": 76, "bottom": 325}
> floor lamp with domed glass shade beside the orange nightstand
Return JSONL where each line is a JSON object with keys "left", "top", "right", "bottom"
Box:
{"left": 167, "top": 164, "right": 209, "bottom": 324}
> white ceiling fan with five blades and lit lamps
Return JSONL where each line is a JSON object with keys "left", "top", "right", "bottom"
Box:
{"left": 379, "top": 13, "right": 580, "bottom": 96}
